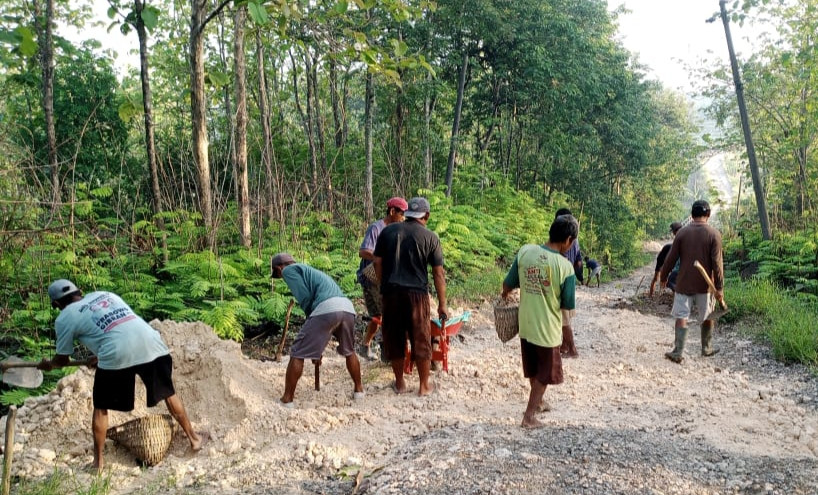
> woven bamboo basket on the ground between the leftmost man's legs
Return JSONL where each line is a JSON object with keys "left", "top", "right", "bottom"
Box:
{"left": 107, "top": 414, "right": 174, "bottom": 466}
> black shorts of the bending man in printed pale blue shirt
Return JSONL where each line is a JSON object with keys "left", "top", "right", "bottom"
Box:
{"left": 94, "top": 354, "right": 176, "bottom": 412}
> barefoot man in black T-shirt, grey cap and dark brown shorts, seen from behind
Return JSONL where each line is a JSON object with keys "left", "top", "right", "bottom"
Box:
{"left": 374, "top": 198, "right": 446, "bottom": 395}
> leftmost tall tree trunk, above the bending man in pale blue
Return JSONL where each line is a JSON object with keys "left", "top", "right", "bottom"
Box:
{"left": 32, "top": 0, "right": 62, "bottom": 213}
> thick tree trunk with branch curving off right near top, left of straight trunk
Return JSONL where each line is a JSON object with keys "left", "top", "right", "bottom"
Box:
{"left": 189, "top": 0, "right": 216, "bottom": 249}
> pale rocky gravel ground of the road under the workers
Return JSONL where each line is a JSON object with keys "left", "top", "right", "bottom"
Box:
{"left": 0, "top": 252, "right": 818, "bottom": 494}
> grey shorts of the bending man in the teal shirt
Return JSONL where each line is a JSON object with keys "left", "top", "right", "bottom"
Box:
{"left": 290, "top": 311, "right": 355, "bottom": 359}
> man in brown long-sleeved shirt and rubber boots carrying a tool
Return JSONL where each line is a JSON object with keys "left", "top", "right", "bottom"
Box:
{"left": 659, "top": 199, "right": 724, "bottom": 363}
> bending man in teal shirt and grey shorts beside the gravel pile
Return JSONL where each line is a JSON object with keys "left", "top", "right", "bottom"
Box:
{"left": 270, "top": 253, "right": 366, "bottom": 408}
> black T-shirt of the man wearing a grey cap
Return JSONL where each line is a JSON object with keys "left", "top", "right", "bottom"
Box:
{"left": 375, "top": 220, "right": 443, "bottom": 294}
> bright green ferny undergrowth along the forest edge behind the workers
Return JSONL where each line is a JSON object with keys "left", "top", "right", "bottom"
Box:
{"left": 0, "top": 184, "right": 652, "bottom": 403}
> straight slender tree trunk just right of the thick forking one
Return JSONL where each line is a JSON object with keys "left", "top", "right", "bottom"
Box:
{"left": 233, "top": 6, "right": 252, "bottom": 248}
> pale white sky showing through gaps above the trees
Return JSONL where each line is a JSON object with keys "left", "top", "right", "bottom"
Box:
{"left": 70, "top": 0, "right": 764, "bottom": 94}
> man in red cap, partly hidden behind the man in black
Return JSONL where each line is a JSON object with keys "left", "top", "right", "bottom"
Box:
{"left": 357, "top": 197, "right": 409, "bottom": 360}
